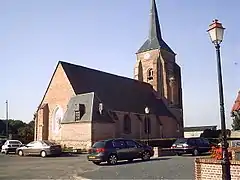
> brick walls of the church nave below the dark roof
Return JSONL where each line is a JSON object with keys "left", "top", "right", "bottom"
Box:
{"left": 35, "top": 64, "right": 182, "bottom": 149}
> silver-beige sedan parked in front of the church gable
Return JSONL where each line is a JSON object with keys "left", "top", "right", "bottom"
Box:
{"left": 16, "top": 140, "right": 62, "bottom": 157}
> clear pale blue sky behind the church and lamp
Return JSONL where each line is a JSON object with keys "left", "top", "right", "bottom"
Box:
{"left": 0, "top": 0, "right": 240, "bottom": 129}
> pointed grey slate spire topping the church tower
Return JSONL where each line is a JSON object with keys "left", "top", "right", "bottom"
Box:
{"left": 137, "top": 0, "right": 175, "bottom": 54}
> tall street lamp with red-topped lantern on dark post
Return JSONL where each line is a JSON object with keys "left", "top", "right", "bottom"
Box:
{"left": 207, "top": 19, "right": 231, "bottom": 180}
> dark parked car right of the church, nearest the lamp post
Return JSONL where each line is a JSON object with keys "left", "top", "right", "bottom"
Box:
{"left": 171, "top": 137, "right": 211, "bottom": 156}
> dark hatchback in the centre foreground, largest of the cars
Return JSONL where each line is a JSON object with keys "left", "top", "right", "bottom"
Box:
{"left": 87, "top": 139, "right": 154, "bottom": 165}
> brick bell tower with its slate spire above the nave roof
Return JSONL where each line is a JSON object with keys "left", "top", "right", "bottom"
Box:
{"left": 134, "top": 0, "right": 182, "bottom": 109}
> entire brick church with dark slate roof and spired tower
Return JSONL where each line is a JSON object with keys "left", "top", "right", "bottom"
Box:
{"left": 34, "top": 0, "right": 183, "bottom": 149}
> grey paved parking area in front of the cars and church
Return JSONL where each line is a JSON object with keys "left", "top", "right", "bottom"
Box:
{"left": 0, "top": 154, "right": 197, "bottom": 180}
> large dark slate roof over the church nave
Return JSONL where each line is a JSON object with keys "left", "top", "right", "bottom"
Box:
{"left": 59, "top": 61, "right": 175, "bottom": 118}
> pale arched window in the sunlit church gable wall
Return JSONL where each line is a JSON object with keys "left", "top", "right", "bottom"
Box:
{"left": 52, "top": 106, "right": 63, "bottom": 134}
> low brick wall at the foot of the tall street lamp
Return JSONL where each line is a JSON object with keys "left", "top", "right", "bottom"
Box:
{"left": 195, "top": 158, "right": 240, "bottom": 180}
